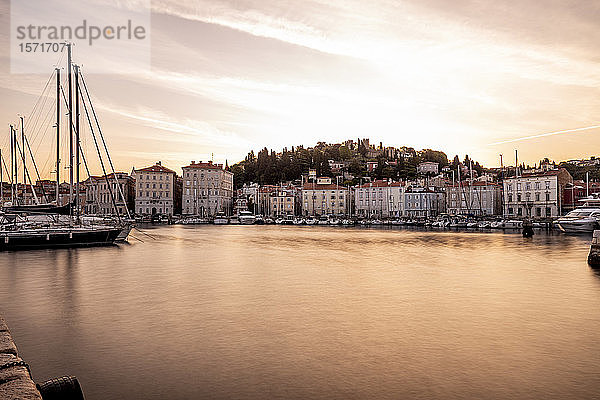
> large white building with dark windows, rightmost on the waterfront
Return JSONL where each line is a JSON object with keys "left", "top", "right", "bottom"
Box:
{"left": 503, "top": 168, "right": 573, "bottom": 218}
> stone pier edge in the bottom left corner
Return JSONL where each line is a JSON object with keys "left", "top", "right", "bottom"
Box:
{"left": 0, "top": 316, "right": 42, "bottom": 400}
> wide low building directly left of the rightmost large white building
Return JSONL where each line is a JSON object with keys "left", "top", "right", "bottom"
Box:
{"left": 446, "top": 181, "right": 502, "bottom": 215}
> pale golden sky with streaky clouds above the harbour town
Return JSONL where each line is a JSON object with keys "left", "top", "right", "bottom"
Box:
{"left": 0, "top": 0, "right": 600, "bottom": 176}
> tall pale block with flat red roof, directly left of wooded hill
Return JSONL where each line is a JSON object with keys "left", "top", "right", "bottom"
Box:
{"left": 182, "top": 161, "right": 233, "bottom": 217}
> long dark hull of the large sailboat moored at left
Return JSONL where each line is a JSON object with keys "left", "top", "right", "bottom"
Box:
{"left": 0, "top": 228, "right": 123, "bottom": 251}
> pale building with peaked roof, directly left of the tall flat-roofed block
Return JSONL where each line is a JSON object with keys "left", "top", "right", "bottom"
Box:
{"left": 132, "top": 161, "right": 177, "bottom": 216}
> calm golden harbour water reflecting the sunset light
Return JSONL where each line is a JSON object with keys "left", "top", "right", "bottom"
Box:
{"left": 0, "top": 226, "right": 600, "bottom": 400}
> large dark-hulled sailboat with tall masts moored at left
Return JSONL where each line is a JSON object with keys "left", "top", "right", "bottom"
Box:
{"left": 0, "top": 44, "right": 131, "bottom": 251}
